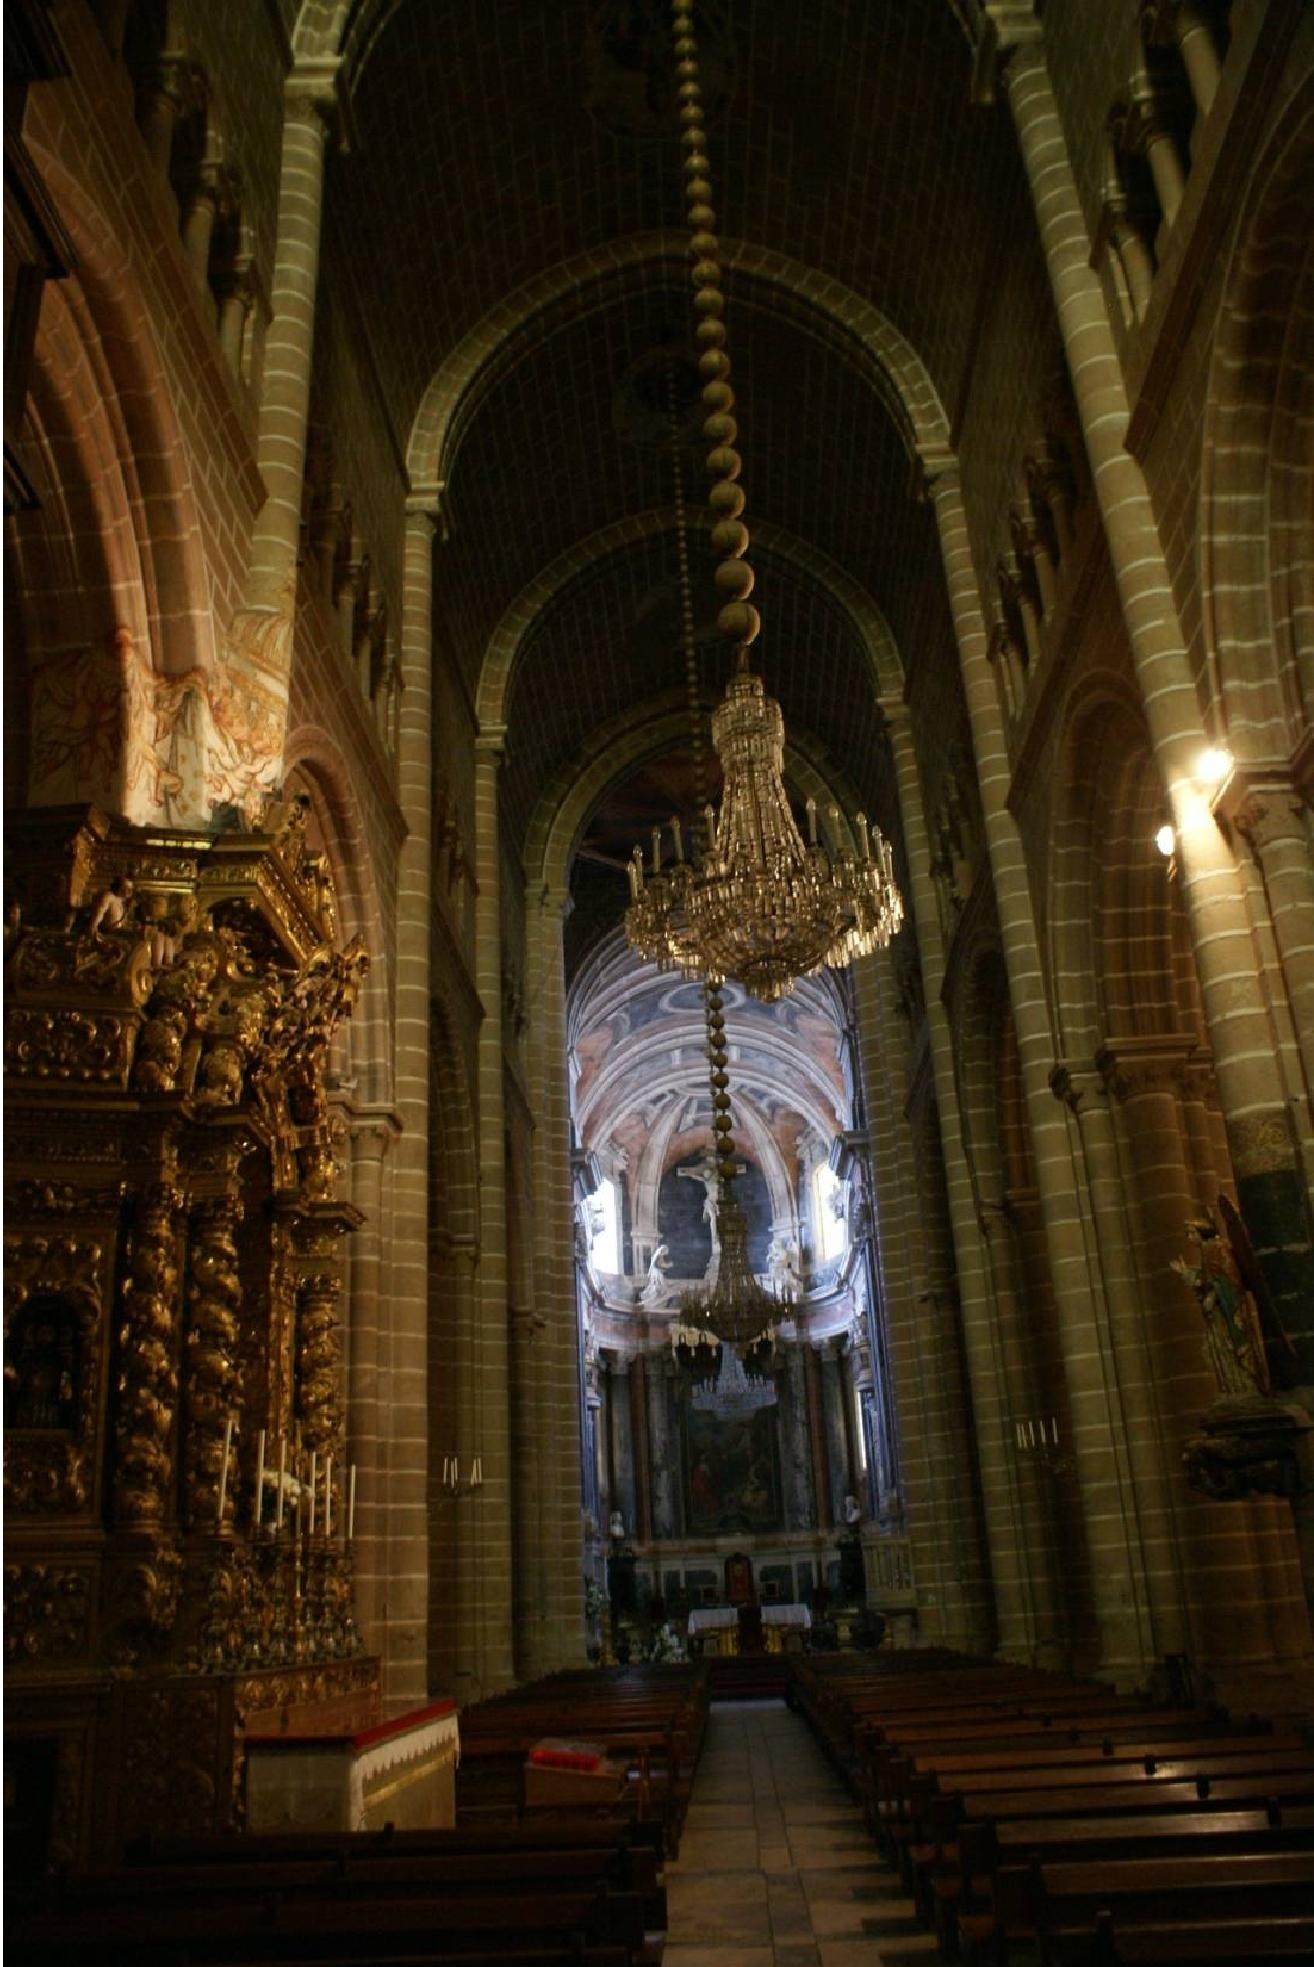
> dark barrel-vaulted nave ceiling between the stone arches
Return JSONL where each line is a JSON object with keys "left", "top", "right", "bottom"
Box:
{"left": 332, "top": 0, "right": 1017, "bottom": 944}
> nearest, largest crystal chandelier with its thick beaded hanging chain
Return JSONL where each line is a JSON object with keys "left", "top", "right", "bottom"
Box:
{"left": 626, "top": 0, "right": 903, "bottom": 1003}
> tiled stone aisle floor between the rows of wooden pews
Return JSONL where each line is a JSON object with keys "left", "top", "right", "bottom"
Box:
{"left": 665, "top": 1701, "right": 934, "bottom": 1967}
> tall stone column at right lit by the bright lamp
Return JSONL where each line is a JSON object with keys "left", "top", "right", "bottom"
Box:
{"left": 1005, "top": 42, "right": 1314, "bottom": 1379}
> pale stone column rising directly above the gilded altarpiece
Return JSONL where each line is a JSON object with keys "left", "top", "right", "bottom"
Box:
{"left": 224, "top": 55, "right": 338, "bottom": 810}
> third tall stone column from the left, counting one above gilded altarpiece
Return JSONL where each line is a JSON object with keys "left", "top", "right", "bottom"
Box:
{"left": 470, "top": 724, "right": 515, "bottom": 1696}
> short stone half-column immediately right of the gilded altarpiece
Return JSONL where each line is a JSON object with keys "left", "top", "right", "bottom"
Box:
{"left": 344, "top": 1111, "right": 395, "bottom": 1692}
